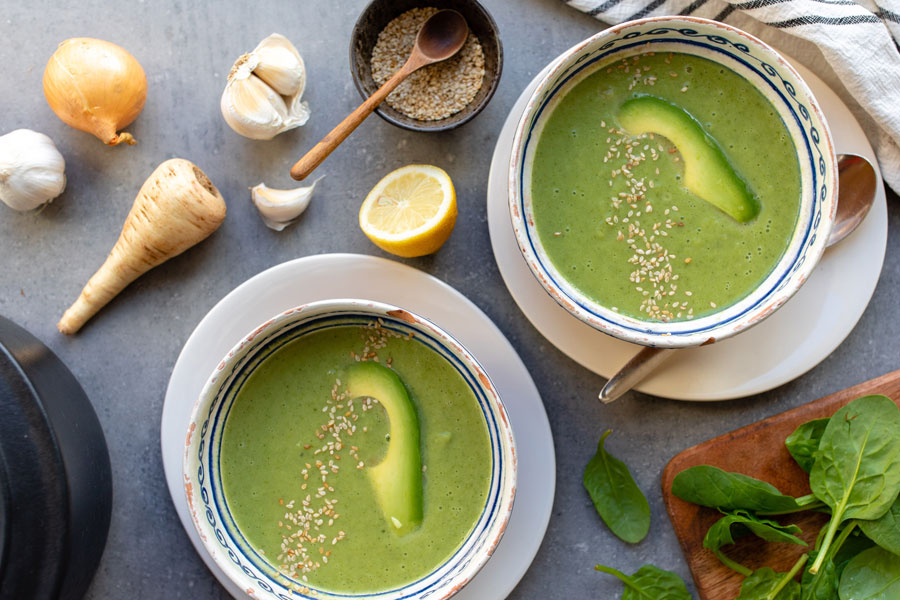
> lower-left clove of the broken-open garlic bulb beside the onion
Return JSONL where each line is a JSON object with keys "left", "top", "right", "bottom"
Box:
{"left": 220, "top": 73, "right": 289, "bottom": 140}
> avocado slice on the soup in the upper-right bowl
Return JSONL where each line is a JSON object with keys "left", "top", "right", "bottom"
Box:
{"left": 618, "top": 95, "right": 760, "bottom": 223}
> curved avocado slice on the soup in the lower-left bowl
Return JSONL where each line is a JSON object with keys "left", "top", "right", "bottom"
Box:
{"left": 346, "top": 362, "right": 422, "bottom": 535}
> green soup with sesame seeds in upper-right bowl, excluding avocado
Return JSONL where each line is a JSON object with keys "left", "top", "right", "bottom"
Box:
{"left": 531, "top": 53, "right": 801, "bottom": 321}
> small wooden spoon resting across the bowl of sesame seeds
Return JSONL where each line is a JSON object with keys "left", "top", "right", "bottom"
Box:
{"left": 291, "top": 10, "right": 469, "bottom": 181}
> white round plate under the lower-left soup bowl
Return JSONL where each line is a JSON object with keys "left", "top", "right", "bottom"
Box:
{"left": 160, "top": 254, "right": 556, "bottom": 600}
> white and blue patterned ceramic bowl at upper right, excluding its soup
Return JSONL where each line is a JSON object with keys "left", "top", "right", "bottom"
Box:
{"left": 509, "top": 17, "right": 837, "bottom": 348}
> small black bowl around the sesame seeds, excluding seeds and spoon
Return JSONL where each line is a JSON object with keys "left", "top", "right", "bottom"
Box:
{"left": 350, "top": 0, "right": 503, "bottom": 131}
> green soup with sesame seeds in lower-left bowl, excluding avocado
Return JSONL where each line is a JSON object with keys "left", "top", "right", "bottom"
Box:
{"left": 220, "top": 325, "right": 491, "bottom": 593}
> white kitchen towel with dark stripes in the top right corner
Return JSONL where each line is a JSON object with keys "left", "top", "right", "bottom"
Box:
{"left": 563, "top": 0, "right": 900, "bottom": 193}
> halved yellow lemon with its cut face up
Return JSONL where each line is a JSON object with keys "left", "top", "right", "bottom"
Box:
{"left": 359, "top": 165, "right": 456, "bottom": 257}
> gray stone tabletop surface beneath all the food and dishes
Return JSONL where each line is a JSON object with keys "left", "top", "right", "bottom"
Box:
{"left": 0, "top": 0, "right": 900, "bottom": 599}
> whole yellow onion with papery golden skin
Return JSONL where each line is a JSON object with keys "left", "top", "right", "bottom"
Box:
{"left": 44, "top": 38, "right": 147, "bottom": 146}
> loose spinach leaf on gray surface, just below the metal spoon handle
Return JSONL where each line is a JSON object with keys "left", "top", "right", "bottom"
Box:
{"left": 584, "top": 430, "right": 650, "bottom": 544}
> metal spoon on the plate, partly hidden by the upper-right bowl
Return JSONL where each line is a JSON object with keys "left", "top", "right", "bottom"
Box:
{"left": 600, "top": 154, "right": 876, "bottom": 404}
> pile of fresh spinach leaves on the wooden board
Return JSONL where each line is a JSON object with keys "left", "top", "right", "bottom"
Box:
{"left": 668, "top": 395, "right": 900, "bottom": 600}
